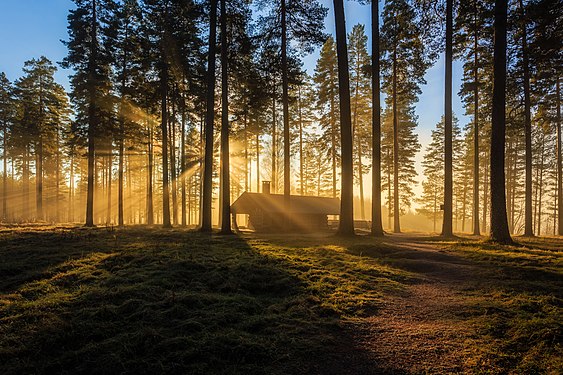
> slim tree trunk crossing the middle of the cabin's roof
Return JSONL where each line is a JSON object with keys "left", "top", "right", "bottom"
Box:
{"left": 281, "top": 0, "right": 291, "bottom": 225}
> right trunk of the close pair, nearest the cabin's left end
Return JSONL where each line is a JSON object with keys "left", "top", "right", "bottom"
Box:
{"left": 221, "top": 0, "right": 232, "bottom": 234}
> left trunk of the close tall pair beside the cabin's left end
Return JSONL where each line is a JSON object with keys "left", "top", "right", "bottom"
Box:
{"left": 201, "top": 0, "right": 217, "bottom": 232}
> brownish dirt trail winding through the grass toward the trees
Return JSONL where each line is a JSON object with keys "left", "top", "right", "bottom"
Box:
{"left": 338, "top": 234, "right": 483, "bottom": 374}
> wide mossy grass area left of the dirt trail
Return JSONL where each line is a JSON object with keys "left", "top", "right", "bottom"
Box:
{"left": 0, "top": 228, "right": 412, "bottom": 374}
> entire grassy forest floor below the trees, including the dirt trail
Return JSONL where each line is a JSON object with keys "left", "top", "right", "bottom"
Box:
{"left": 0, "top": 227, "right": 563, "bottom": 374}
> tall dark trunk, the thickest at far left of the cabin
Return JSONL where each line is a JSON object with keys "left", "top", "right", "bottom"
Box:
{"left": 85, "top": 0, "right": 98, "bottom": 227}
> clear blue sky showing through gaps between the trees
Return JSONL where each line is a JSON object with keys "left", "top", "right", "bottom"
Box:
{"left": 0, "top": 0, "right": 469, "bottom": 203}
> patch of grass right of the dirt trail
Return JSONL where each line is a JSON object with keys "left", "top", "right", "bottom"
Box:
{"left": 447, "top": 238, "right": 563, "bottom": 374}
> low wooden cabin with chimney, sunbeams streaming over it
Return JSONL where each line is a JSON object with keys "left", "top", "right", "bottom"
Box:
{"left": 231, "top": 181, "right": 340, "bottom": 232}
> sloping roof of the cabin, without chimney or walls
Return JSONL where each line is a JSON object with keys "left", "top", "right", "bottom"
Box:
{"left": 231, "top": 192, "right": 340, "bottom": 215}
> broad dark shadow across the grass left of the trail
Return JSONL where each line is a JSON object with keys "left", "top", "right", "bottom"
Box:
{"left": 0, "top": 230, "right": 384, "bottom": 374}
